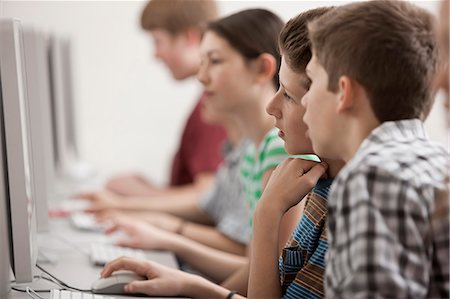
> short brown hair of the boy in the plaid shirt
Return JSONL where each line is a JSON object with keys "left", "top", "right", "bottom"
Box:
{"left": 308, "top": 0, "right": 438, "bottom": 122}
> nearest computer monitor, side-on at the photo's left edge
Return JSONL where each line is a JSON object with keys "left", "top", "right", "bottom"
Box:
{"left": 0, "top": 18, "right": 37, "bottom": 283}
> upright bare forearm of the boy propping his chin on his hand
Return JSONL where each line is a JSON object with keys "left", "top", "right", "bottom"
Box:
{"left": 248, "top": 201, "right": 283, "bottom": 298}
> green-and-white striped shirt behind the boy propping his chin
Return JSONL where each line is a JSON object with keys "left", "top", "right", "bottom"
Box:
{"left": 240, "top": 128, "right": 288, "bottom": 225}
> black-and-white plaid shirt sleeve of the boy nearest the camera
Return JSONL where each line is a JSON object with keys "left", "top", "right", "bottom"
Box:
{"left": 326, "top": 168, "right": 440, "bottom": 298}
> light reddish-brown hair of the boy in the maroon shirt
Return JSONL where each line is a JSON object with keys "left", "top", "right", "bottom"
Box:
{"left": 141, "top": 0, "right": 218, "bottom": 35}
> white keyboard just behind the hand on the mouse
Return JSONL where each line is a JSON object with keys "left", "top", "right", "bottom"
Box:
{"left": 90, "top": 243, "right": 147, "bottom": 266}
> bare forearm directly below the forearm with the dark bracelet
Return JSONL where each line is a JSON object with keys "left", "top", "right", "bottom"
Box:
{"left": 165, "top": 236, "right": 247, "bottom": 281}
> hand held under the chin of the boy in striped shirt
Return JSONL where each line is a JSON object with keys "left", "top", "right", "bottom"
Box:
{"left": 258, "top": 158, "right": 328, "bottom": 214}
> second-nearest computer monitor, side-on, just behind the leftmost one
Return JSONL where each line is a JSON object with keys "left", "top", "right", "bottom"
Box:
{"left": 23, "top": 26, "right": 55, "bottom": 232}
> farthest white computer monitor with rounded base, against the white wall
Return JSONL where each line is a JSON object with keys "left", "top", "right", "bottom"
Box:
{"left": 49, "top": 36, "right": 92, "bottom": 180}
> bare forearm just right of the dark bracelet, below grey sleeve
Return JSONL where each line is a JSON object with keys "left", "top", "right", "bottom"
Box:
{"left": 180, "top": 222, "right": 247, "bottom": 256}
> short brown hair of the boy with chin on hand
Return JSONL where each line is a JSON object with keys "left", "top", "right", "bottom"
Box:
{"left": 278, "top": 7, "right": 332, "bottom": 73}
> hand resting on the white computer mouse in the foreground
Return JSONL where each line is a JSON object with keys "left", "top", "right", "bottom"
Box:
{"left": 101, "top": 257, "right": 192, "bottom": 296}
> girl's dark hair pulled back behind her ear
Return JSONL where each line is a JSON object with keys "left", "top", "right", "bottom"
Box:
{"left": 206, "top": 9, "right": 284, "bottom": 88}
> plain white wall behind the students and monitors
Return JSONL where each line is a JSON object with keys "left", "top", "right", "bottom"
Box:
{"left": 0, "top": 0, "right": 448, "bottom": 188}
